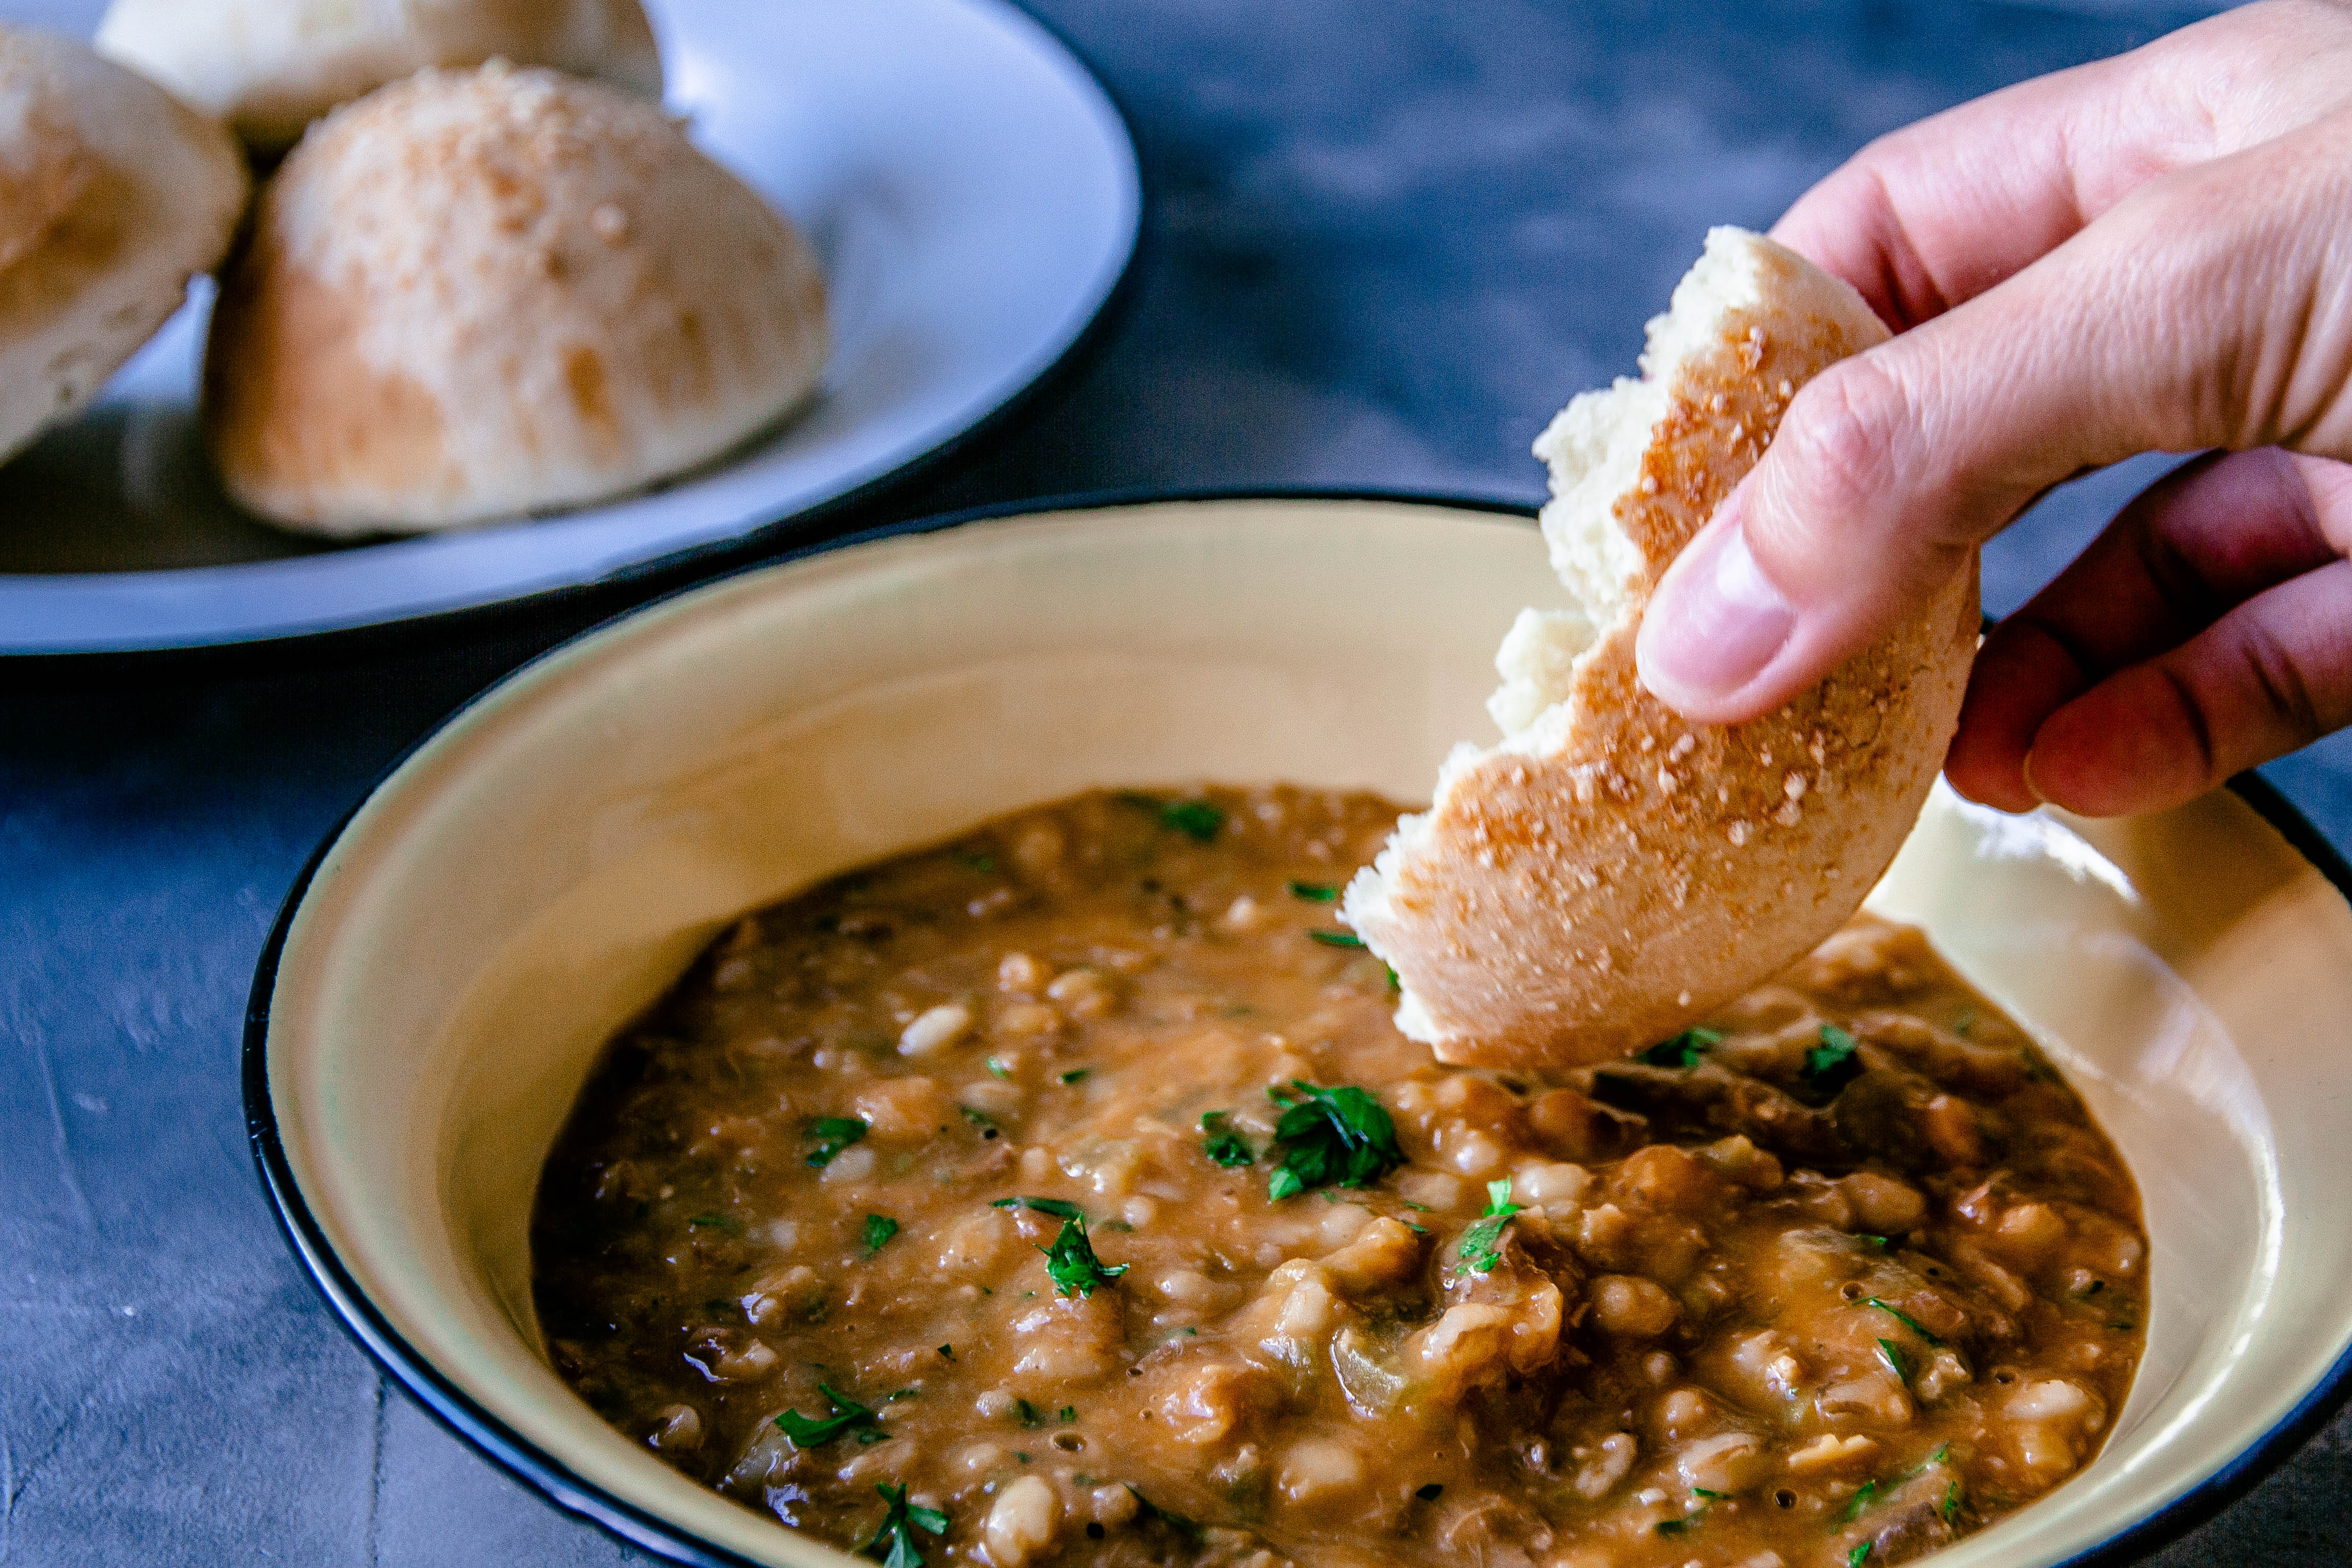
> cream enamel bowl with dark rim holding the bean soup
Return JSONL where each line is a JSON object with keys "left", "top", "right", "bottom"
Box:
{"left": 245, "top": 498, "right": 2352, "bottom": 1568}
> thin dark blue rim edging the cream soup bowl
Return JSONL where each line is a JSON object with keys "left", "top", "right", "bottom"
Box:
{"left": 240, "top": 489, "right": 2352, "bottom": 1568}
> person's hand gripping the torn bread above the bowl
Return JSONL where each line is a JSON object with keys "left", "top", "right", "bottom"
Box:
{"left": 1639, "top": 0, "right": 2352, "bottom": 816}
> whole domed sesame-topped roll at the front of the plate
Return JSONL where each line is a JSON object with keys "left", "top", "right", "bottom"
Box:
{"left": 205, "top": 61, "right": 826, "bottom": 534}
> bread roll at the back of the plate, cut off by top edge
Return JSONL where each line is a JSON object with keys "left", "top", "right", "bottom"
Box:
{"left": 96, "top": 0, "right": 661, "bottom": 153}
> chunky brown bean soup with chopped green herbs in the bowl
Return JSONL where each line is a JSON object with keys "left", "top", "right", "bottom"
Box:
{"left": 532, "top": 787, "right": 2147, "bottom": 1568}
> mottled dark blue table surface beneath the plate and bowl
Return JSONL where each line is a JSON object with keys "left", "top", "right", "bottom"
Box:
{"left": 0, "top": 0, "right": 2352, "bottom": 1568}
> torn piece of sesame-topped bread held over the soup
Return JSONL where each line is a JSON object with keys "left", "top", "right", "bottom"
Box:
{"left": 1345, "top": 228, "right": 1978, "bottom": 1067}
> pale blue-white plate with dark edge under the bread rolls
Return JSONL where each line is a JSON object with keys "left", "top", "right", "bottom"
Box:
{"left": 0, "top": 0, "right": 1141, "bottom": 653}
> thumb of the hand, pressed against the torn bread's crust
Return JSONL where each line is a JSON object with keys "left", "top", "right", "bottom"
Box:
{"left": 1637, "top": 127, "right": 2352, "bottom": 724}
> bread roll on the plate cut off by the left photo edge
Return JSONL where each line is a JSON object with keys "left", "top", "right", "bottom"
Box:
{"left": 0, "top": 26, "right": 245, "bottom": 458}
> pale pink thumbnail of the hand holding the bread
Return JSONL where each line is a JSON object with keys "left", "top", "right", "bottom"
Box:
{"left": 1642, "top": 503, "right": 1797, "bottom": 705}
